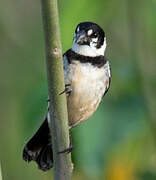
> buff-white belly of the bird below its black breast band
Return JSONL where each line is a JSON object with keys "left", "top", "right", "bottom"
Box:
{"left": 67, "top": 63, "right": 107, "bottom": 127}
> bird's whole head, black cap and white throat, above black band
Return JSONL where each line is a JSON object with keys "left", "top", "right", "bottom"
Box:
{"left": 72, "top": 22, "right": 106, "bottom": 56}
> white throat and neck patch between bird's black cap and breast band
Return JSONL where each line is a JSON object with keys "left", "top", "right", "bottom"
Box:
{"left": 72, "top": 38, "right": 106, "bottom": 57}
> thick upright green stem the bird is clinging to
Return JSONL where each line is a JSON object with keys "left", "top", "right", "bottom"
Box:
{"left": 41, "top": 0, "right": 72, "bottom": 180}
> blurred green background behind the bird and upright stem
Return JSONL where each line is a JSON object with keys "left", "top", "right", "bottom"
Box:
{"left": 0, "top": 0, "right": 156, "bottom": 180}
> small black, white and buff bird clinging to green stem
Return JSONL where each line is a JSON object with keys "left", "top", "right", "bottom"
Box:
{"left": 23, "top": 22, "right": 111, "bottom": 171}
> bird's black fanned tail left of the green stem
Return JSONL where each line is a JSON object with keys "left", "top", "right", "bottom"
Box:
{"left": 23, "top": 118, "right": 53, "bottom": 171}
